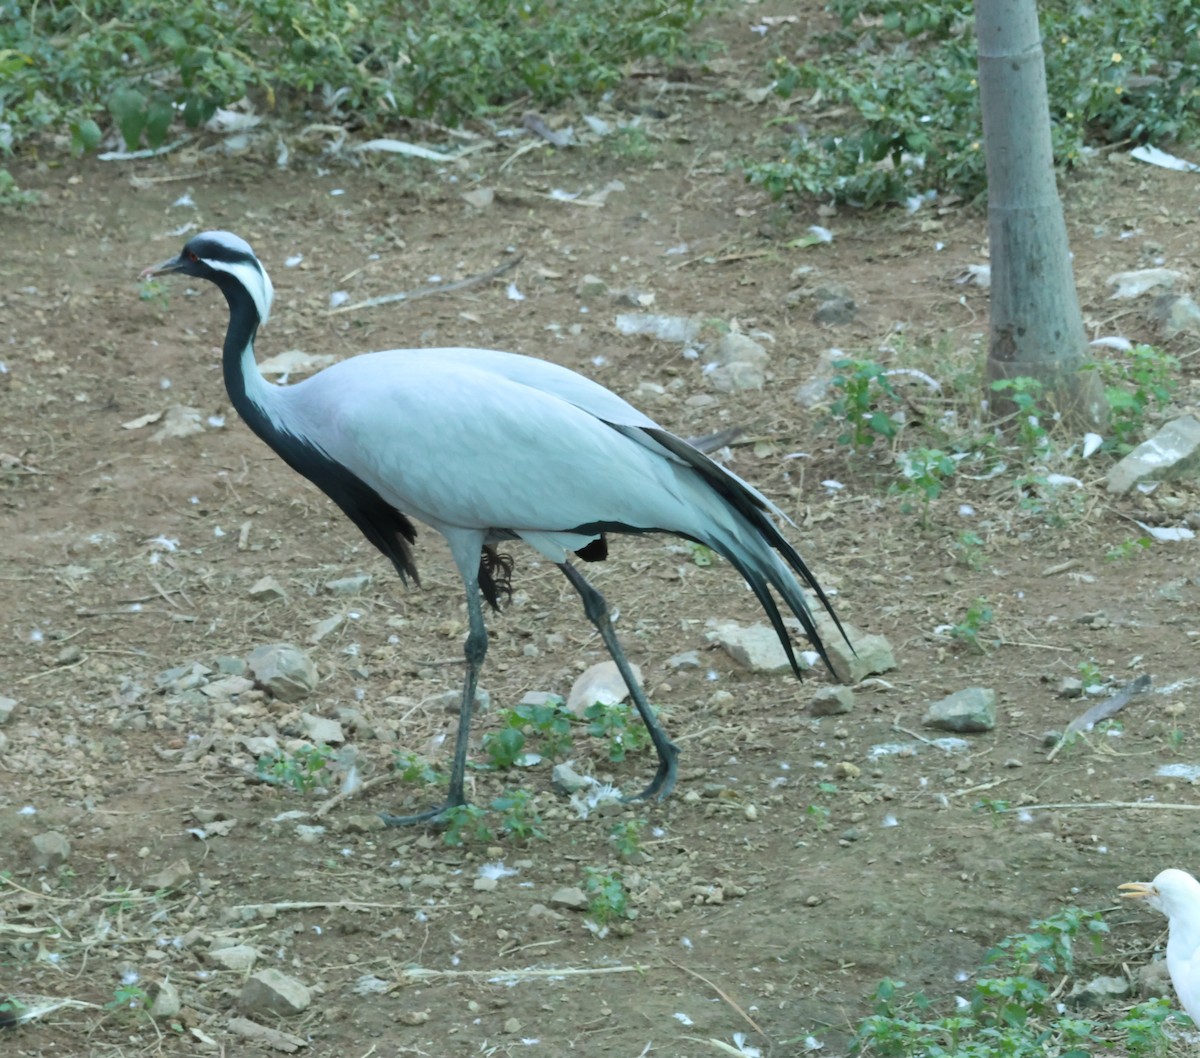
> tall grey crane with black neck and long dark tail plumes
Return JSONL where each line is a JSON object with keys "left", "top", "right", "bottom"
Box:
{"left": 142, "top": 232, "right": 845, "bottom": 825}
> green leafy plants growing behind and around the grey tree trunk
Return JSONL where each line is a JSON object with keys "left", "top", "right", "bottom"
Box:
{"left": 745, "top": 0, "right": 1200, "bottom": 206}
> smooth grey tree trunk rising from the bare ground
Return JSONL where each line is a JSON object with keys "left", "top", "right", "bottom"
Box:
{"left": 974, "top": 0, "right": 1108, "bottom": 428}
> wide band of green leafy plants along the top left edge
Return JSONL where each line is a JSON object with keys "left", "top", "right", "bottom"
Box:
{"left": 0, "top": 0, "right": 708, "bottom": 151}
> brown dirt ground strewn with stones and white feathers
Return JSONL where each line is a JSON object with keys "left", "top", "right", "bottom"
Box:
{"left": 0, "top": 6, "right": 1200, "bottom": 1058}
